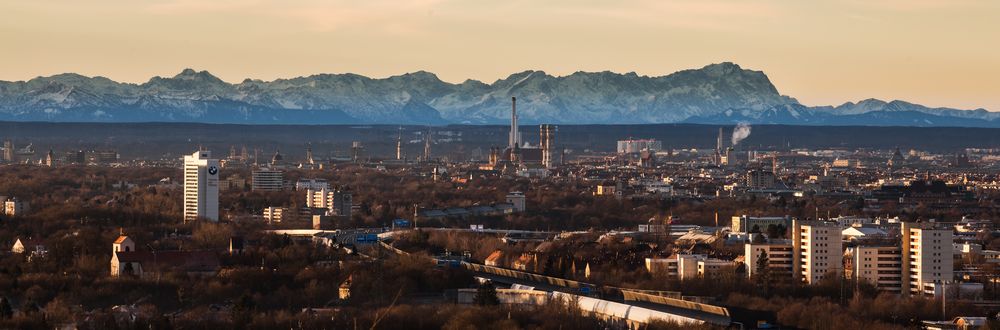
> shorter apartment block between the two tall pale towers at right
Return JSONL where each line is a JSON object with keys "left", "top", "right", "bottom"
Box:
{"left": 851, "top": 245, "right": 903, "bottom": 293}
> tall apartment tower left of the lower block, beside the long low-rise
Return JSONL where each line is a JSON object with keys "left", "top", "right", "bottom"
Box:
{"left": 792, "top": 220, "right": 844, "bottom": 284}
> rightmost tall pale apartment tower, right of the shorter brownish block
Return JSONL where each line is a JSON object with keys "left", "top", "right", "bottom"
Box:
{"left": 901, "top": 223, "right": 955, "bottom": 295}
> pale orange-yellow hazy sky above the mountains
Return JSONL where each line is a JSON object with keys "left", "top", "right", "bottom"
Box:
{"left": 0, "top": 0, "right": 1000, "bottom": 111}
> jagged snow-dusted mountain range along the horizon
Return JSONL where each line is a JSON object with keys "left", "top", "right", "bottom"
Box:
{"left": 0, "top": 62, "right": 1000, "bottom": 127}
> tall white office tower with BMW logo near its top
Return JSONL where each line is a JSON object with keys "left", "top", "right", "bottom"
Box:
{"left": 184, "top": 150, "right": 219, "bottom": 222}
